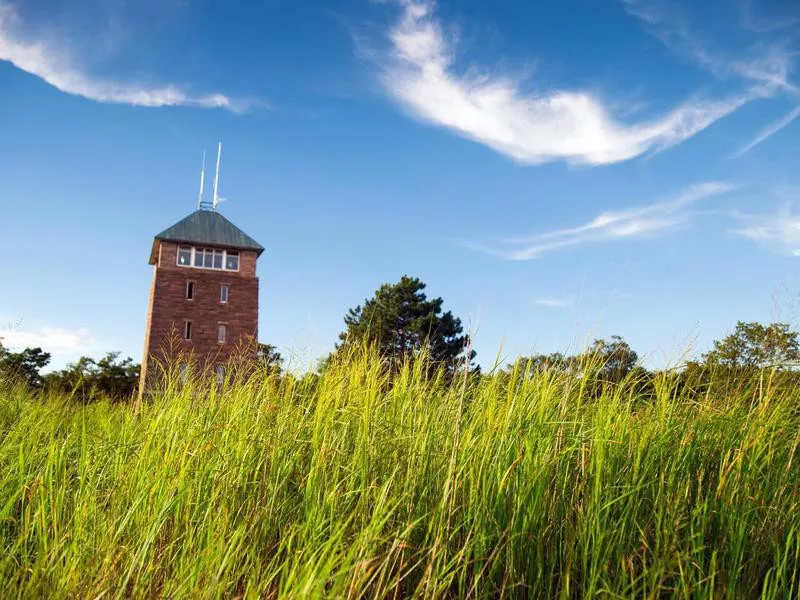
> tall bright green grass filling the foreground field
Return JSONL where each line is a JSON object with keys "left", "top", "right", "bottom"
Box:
{"left": 0, "top": 350, "right": 800, "bottom": 598}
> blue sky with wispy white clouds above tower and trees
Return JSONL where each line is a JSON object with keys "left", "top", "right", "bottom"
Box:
{"left": 0, "top": 0, "right": 800, "bottom": 366}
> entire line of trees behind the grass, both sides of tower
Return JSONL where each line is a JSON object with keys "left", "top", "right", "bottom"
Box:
{"left": 0, "top": 276, "right": 800, "bottom": 402}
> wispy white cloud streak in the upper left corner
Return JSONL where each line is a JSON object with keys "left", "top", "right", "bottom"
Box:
{"left": 0, "top": 0, "right": 255, "bottom": 113}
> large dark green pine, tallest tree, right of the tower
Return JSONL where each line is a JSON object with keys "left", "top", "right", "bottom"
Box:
{"left": 337, "top": 275, "right": 475, "bottom": 372}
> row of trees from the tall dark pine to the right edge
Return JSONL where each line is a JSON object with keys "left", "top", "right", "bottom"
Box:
{"left": 322, "top": 276, "right": 800, "bottom": 396}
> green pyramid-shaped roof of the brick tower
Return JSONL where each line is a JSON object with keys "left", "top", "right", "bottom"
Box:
{"left": 150, "top": 210, "right": 264, "bottom": 263}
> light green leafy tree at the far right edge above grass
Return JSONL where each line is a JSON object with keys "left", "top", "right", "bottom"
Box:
{"left": 702, "top": 321, "right": 800, "bottom": 369}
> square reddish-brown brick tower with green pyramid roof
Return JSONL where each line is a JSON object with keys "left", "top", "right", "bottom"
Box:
{"left": 140, "top": 206, "right": 264, "bottom": 392}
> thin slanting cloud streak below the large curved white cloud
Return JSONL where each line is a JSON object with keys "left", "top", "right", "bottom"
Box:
{"left": 469, "top": 182, "right": 735, "bottom": 260}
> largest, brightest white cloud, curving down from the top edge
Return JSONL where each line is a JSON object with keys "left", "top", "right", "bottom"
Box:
{"left": 382, "top": 0, "right": 761, "bottom": 165}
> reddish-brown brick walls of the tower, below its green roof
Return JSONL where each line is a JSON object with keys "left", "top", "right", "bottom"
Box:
{"left": 142, "top": 241, "right": 258, "bottom": 382}
